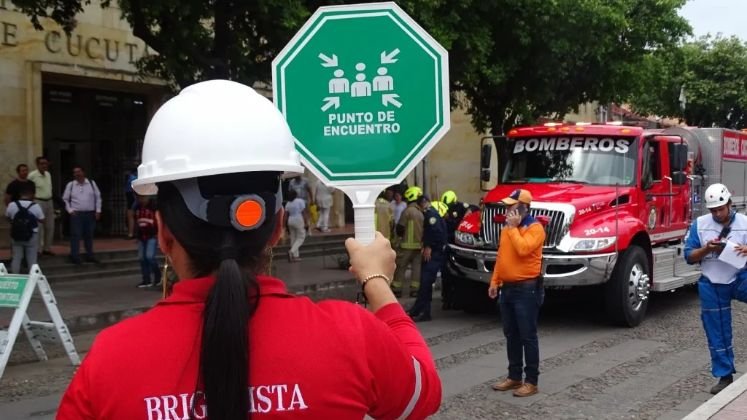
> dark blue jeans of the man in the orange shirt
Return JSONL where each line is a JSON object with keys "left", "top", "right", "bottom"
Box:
{"left": 498, "top": 280, "right": 545, "bottom": 385}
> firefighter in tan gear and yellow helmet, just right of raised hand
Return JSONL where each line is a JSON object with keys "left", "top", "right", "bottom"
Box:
{"left": 392, "top": 186, "right": 423, "bottom": 297}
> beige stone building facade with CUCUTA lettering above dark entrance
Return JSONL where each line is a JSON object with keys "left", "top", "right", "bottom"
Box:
{"left": 0, "top": 0, "right": 482, "bottom": 243}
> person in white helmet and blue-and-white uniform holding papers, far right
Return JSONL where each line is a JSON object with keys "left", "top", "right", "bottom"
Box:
{"left": 685, "top": 184, "right": 747, "bottom": 394}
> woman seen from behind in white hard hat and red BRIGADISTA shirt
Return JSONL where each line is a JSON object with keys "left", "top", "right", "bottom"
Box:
{"left": 58, "top": 80, "right": 441, "bottom": 420}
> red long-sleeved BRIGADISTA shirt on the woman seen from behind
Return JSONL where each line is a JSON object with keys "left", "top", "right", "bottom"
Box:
{"left": 57, "top": 277, "right": 441, "bottom": 420}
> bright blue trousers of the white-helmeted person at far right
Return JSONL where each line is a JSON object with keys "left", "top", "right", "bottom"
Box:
{"left": 698, "top": 277, "right": 747, "bottom": 378}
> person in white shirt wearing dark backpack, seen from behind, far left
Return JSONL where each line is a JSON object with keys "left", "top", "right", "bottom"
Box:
{"left": 5, "top": 182, "right": 44, "bottom": 274}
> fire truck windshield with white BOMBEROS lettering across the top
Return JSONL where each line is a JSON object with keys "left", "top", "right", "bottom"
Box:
{"left": 502, "top": 136, "right": 637, "bottom": 185}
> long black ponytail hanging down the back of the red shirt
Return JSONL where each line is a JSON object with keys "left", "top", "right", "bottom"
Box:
{"left": 200, "top": 259, "right": 259, "bottom": 420}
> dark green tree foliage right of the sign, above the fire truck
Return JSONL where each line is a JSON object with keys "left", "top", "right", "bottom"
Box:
{"left": 436, "top": 0, "right": 690, "bottom": 133}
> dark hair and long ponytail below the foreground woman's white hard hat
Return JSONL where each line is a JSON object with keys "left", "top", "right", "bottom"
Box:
{"left": 158, "top": 172, "right": 280, "bottom": 420}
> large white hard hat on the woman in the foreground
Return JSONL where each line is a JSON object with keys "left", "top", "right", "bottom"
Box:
{"left": 132, "top": 80, "right": 303, "bottom": 195}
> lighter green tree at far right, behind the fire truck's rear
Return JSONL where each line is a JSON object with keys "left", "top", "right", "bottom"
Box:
{"left": 631, "top": 37, "right": 747, "bottom": 128}
